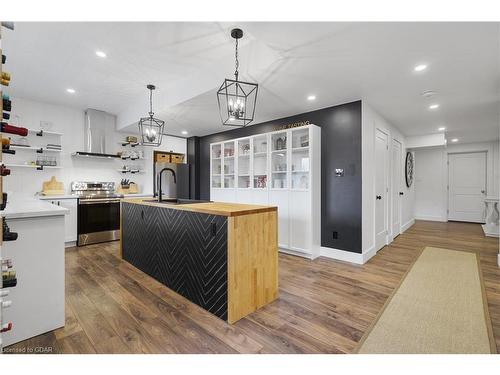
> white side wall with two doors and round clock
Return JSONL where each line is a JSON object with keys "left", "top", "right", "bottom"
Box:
{"left": 361, "top": 101, "right": 415, "bottom": 261}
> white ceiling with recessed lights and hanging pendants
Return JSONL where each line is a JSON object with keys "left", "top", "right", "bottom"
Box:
{"left": 3, "top": 22, "right": 500, "bottom": 142}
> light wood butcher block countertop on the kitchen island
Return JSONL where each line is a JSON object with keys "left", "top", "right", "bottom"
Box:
{"left": 122, "top": 198, "right": 278, "bottom": 216}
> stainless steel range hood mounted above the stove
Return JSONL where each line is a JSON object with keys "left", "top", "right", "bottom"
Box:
{"left": 74, "top": 108, "right": 119, "bottom": 158}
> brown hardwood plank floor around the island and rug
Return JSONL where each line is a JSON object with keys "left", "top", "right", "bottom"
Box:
{"left": 5, "top": 221, "right": 500, "bottom": 353}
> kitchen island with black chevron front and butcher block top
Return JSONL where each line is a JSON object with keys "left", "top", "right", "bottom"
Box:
{"left": 121, "top": 199, "right": 278, "bottom": 323}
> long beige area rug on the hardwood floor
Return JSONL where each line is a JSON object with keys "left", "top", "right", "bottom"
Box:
{"left": 357, "top": 247, "right": 496, "bottom": 354}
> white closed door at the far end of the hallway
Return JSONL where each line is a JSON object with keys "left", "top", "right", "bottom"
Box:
{"left": 448, "top": 152, "right": 486, "bottom": 223}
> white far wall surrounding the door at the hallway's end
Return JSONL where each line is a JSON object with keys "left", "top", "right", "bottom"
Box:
{"left": 415, "top": 141, "right": 500, "bottom": 221}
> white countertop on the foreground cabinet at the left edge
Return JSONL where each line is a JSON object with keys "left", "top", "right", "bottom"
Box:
{"left": 0, "top": 198, "right": 69, "bottom": 219}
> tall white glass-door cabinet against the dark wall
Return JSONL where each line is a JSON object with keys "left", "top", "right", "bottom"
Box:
{"left": 210, "top": 125, "right": 321, "bottom": 258}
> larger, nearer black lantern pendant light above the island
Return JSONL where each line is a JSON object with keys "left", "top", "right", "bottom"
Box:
{"left": 217, "top": 29, "right": 259, "bottom": 126}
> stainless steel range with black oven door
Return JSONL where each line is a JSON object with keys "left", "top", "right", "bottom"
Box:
{"left": 71, "top": 181, "right": 123, "bottom": 246}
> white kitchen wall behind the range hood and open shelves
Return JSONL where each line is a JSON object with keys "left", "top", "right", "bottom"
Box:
{"left": 3, "top": 98, "right": 187, "bottom": 200}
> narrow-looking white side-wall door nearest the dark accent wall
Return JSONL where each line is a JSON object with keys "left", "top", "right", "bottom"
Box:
{"left": 375, "top": 129, "right": 388, "bottom": 251}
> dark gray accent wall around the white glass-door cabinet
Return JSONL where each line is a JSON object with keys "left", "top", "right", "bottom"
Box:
{"left": 197, "top": 101, "right": 361, "bottom": 253}
